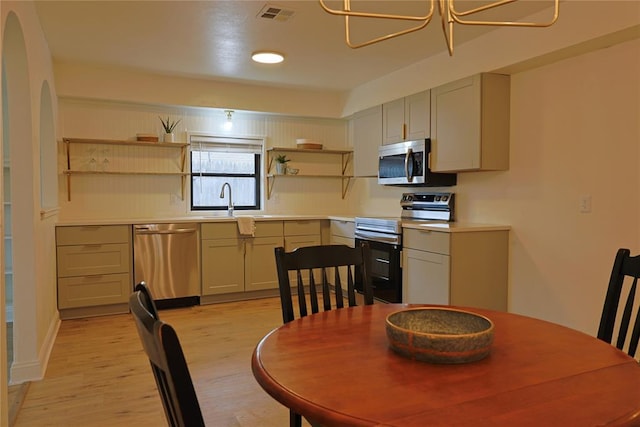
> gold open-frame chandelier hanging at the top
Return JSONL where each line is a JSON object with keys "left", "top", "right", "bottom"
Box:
{"left": 318, "top": 0, "right": 560, "bottom": 56}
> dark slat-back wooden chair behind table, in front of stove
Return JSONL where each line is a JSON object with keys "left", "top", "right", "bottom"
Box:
{"left": 275, "top": 243, "right": 373, "bottom": 427}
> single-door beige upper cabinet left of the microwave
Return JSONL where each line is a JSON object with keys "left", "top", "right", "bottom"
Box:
{"left": 351, "top": 105, "right": 382, "bottom": 176}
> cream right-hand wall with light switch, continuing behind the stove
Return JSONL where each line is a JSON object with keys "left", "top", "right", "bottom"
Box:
{"left": 348, "top": 39, "right": 640, "bottom": 335}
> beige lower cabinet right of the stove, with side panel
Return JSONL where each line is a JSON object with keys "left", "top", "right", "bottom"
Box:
{"left": 402, "top": 229, "right": 509, "bottom": 311}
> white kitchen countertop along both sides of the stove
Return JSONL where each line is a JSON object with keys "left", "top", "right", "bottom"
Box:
{"left": 56, "top": 214, "right": 511, "bottom": 233}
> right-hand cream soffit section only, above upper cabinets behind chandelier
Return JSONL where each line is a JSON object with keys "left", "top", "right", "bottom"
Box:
{"left": 342, "top": 0, "right": 640, "bottom": 116}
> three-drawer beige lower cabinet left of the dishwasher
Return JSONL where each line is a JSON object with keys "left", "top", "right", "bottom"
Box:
{"left": 56, "top": 225, "right": 133, "bottom": 319}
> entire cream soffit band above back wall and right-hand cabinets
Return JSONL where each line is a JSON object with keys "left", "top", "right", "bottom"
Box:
{"left": 54, "top": 0, "right": 640, "bottom": 118}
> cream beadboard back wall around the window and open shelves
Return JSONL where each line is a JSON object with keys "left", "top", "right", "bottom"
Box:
{"left": 58, "top": 98, "right": 349, "bottom": 221}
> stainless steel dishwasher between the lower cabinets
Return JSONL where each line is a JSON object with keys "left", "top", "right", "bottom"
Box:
{"left": 133, "top": 223, "right": 200, "bottom": 308}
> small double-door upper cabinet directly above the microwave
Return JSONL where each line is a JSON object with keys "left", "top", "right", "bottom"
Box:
{"left": 382, "top": 90, "right": 431, "bottom": 144}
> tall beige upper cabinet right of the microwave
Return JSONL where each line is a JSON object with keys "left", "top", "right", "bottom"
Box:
{"left": 430, "top": 73, "right": 510, "bottom": 172}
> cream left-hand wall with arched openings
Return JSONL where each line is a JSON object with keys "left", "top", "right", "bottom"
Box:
{"left": 0, "top": 2, "right": 59, "bottom": 394}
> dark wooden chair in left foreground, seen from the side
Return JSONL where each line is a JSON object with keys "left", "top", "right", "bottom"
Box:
{"left": 129, "top": 285, "right": 204, "bottom": 427}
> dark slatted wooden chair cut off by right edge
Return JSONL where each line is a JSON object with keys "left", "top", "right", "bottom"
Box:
{"left": 598, "top": 249, "right": 640, "bottom": 357}
